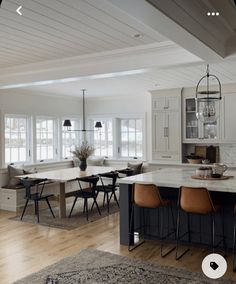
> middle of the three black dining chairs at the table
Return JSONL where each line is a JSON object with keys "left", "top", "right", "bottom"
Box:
{"left": 69, "top": 175, "right": 101, "bottom": 221}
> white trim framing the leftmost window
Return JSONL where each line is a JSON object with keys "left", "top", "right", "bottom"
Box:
{"left": 1, "top": 113, "right": 32, "bottom": 167}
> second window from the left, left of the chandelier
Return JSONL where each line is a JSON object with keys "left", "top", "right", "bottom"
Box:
{"left": 36, "top": 118, "right": 57, "bottom": 161}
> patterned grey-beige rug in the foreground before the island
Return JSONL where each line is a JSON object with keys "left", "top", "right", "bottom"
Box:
{"left": 14, "top": 249, "right": 235, "bottom": 284}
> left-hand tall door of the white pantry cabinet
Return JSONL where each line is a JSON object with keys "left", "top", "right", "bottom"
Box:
{"left": 153, "top": 112, "right": 167, "bottom": 152}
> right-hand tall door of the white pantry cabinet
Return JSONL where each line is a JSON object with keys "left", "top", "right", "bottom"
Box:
{"left": 167, "top": 111, "right": 181, "bottom": 153}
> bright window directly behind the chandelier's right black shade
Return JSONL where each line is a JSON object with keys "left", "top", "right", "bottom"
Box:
{"left": 93, "top": 120, "right": 113, "bottom": 157}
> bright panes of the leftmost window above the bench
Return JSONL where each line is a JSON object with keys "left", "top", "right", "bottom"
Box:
{"left": 5, "top": 115, "right": 29, "bottom": 164}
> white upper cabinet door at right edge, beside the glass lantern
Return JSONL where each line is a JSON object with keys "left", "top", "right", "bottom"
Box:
{"left": 222, "top": 94, "right": 236, "bottom": 142}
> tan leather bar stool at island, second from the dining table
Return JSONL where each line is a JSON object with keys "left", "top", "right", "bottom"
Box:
{"left": 175, "top": 186, "right": 225, "bottom": 260}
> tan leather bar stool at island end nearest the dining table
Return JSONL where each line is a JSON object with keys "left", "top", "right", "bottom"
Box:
{"left": 129, "top": 184, "right": 176, "bottom": 257}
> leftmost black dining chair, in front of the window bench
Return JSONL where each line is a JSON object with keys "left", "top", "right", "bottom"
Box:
{"left": 20, "top": 177, "right": 55, "bottom": 223}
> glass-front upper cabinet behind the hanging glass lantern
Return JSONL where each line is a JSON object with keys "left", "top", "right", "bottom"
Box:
{"left": 183, "top": 97, "right": 220, "bottom": 143}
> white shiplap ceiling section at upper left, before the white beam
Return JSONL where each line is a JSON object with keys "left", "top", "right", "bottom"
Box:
{"left": 0, "top": 0, "right": 167, "bottom": 68}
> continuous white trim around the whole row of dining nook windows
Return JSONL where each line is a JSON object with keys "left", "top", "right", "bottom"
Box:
{"left": 0, "top": 110, "right": 147, "bottom": 168}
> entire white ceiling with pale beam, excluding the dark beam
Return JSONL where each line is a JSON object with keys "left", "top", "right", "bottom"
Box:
{"left": 0, "top": 0, "right": 236, "bottom": 97}
